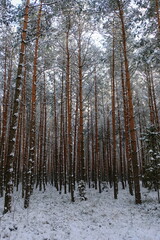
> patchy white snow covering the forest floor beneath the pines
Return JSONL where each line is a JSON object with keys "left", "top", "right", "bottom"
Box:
{"left": 0, "top": 186, "right": 160, "bottom": 240}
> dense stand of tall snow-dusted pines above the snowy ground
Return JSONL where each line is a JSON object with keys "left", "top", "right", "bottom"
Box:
{"left": 0, "top": 0, "right": 160, "bottom": 213}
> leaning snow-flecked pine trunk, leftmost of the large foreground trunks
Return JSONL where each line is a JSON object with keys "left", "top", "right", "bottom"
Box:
{"left": 4, "top": 0, "right": 30, "bottom": 213}
